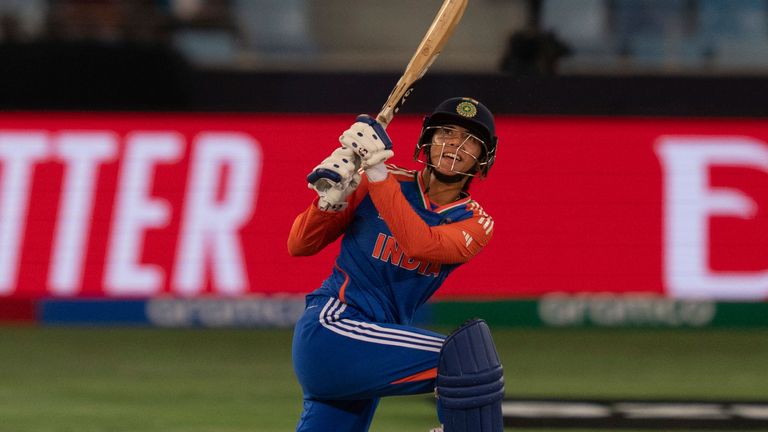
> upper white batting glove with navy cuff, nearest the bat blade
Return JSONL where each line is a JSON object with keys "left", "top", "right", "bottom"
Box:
{"left": 339, "top": 114, "right": 395, "bottom": 170}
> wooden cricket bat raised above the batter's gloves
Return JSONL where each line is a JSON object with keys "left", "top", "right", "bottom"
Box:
{"left": 376, "top": 0, "right": 469, "bottom": 128}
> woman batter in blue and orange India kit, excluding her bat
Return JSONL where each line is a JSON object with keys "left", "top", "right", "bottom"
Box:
{"left": 288, "top": 98, "right": 503, "bottom": 432}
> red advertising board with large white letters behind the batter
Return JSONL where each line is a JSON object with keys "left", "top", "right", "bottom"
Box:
{"left": 0, "top": 113, "right": 768, "bottom": 300}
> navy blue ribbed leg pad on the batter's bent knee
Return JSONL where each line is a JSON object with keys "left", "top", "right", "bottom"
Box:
{"left": 437, "top": 320, "right": 504, "bottom": 432}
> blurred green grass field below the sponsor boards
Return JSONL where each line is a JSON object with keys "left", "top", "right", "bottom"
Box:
{"left": 0, "top": 327, "right": 768, "bottom": 432}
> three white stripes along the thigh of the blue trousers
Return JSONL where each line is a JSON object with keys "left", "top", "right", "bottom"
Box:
{"left": 320, "top": 299, "right": 443, "bottom": 352}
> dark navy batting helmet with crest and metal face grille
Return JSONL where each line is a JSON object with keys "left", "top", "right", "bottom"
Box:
{"left": 414, "top": 97, "right": 498, "bottom": 177}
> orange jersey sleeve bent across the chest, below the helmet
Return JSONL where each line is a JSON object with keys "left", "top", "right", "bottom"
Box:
{"left": 368, "top": 175, "right": 493, "bottom": 264}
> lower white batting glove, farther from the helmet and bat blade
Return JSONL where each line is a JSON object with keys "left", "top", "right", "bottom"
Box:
{"left": 307, "top": 148, "right": 360, "bottom": 212}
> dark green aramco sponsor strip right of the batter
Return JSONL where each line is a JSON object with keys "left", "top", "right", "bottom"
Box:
{"left": 430, "top": 295, "right": 768, "bottom": 328}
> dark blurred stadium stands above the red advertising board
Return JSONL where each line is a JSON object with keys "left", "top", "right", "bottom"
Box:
{"left": 0, "top": 0, "right": 768, "bottom": 115}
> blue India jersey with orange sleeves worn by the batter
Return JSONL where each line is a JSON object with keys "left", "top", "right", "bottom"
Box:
{"left": 288, "top": 166, "right": 493, "bottom": 324}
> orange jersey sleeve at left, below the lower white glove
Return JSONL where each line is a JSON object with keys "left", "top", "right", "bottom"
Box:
{"left": 288, "top": 176, "right": 368, "bottom": 256}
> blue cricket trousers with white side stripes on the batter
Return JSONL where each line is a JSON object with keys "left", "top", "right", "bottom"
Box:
{"left": 293, "top": 296, "right": 445, "bottom": 432}
